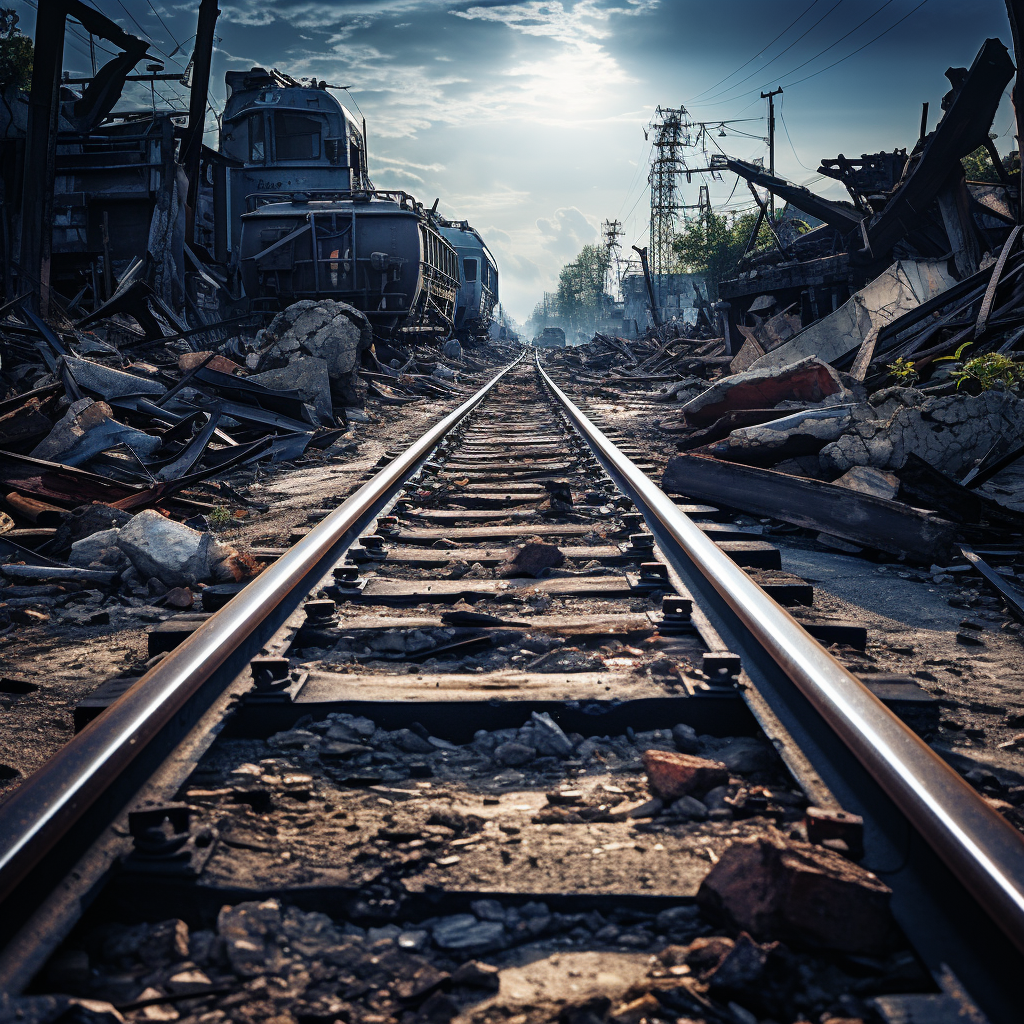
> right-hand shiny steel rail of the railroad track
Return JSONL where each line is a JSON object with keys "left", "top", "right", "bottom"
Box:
{"left": 537, "top": 357, "right": 1024, "bottom": 951}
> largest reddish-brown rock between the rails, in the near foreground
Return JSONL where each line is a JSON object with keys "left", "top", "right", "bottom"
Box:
{"left": 697, "top": 831, "right": 895, "bottom": 954}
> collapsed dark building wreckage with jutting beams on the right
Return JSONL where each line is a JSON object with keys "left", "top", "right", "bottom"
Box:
{"left": 712, "top": 39, "right": 1019, "bottom": 379}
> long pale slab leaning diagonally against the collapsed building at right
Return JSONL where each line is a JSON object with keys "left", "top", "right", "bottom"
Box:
{"left": 751, "top": 260, "right": 956, "bottom": 370}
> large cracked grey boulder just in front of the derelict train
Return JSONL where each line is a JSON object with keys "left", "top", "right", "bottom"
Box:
{"left": 257, "top": 299, "right": 373, "bottom": 406}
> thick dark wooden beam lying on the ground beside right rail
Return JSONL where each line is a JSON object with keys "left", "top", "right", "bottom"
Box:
{"left": 662, "top": 455, "right": 954, "bottom": 565}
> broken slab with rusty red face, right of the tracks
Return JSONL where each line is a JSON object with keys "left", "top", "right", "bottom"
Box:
{"left": 682, "top": 356, "right": 844, "bottom": 426}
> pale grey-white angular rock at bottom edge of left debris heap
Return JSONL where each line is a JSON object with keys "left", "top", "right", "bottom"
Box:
{"left": 117, "top": 509, "right": 237, "bottom": 587}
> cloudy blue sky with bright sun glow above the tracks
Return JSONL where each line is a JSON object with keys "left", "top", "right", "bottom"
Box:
{"left": 8, "top": 0, "right": 1016, "bottom": 322}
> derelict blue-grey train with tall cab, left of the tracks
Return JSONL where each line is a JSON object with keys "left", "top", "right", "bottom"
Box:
{"left": 214, "top": 68, "right": 489, "bottom": 340}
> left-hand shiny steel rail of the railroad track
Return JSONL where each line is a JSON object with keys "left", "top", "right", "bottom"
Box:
{"left": 0, "top": 355, "right": 523, "bottom": 901}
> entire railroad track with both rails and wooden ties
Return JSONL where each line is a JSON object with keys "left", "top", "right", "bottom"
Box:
{"left": 0, "top": 357, "right": 1024, "bottom": 1024}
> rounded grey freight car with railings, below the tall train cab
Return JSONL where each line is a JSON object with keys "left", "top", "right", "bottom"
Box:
{"left": 239, "top": 189, "right": 459, "bottom": 340}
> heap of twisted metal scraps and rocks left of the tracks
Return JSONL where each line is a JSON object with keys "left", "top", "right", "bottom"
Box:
{"left": 0, "top": 292, "right": 489, "bottom": 629}
